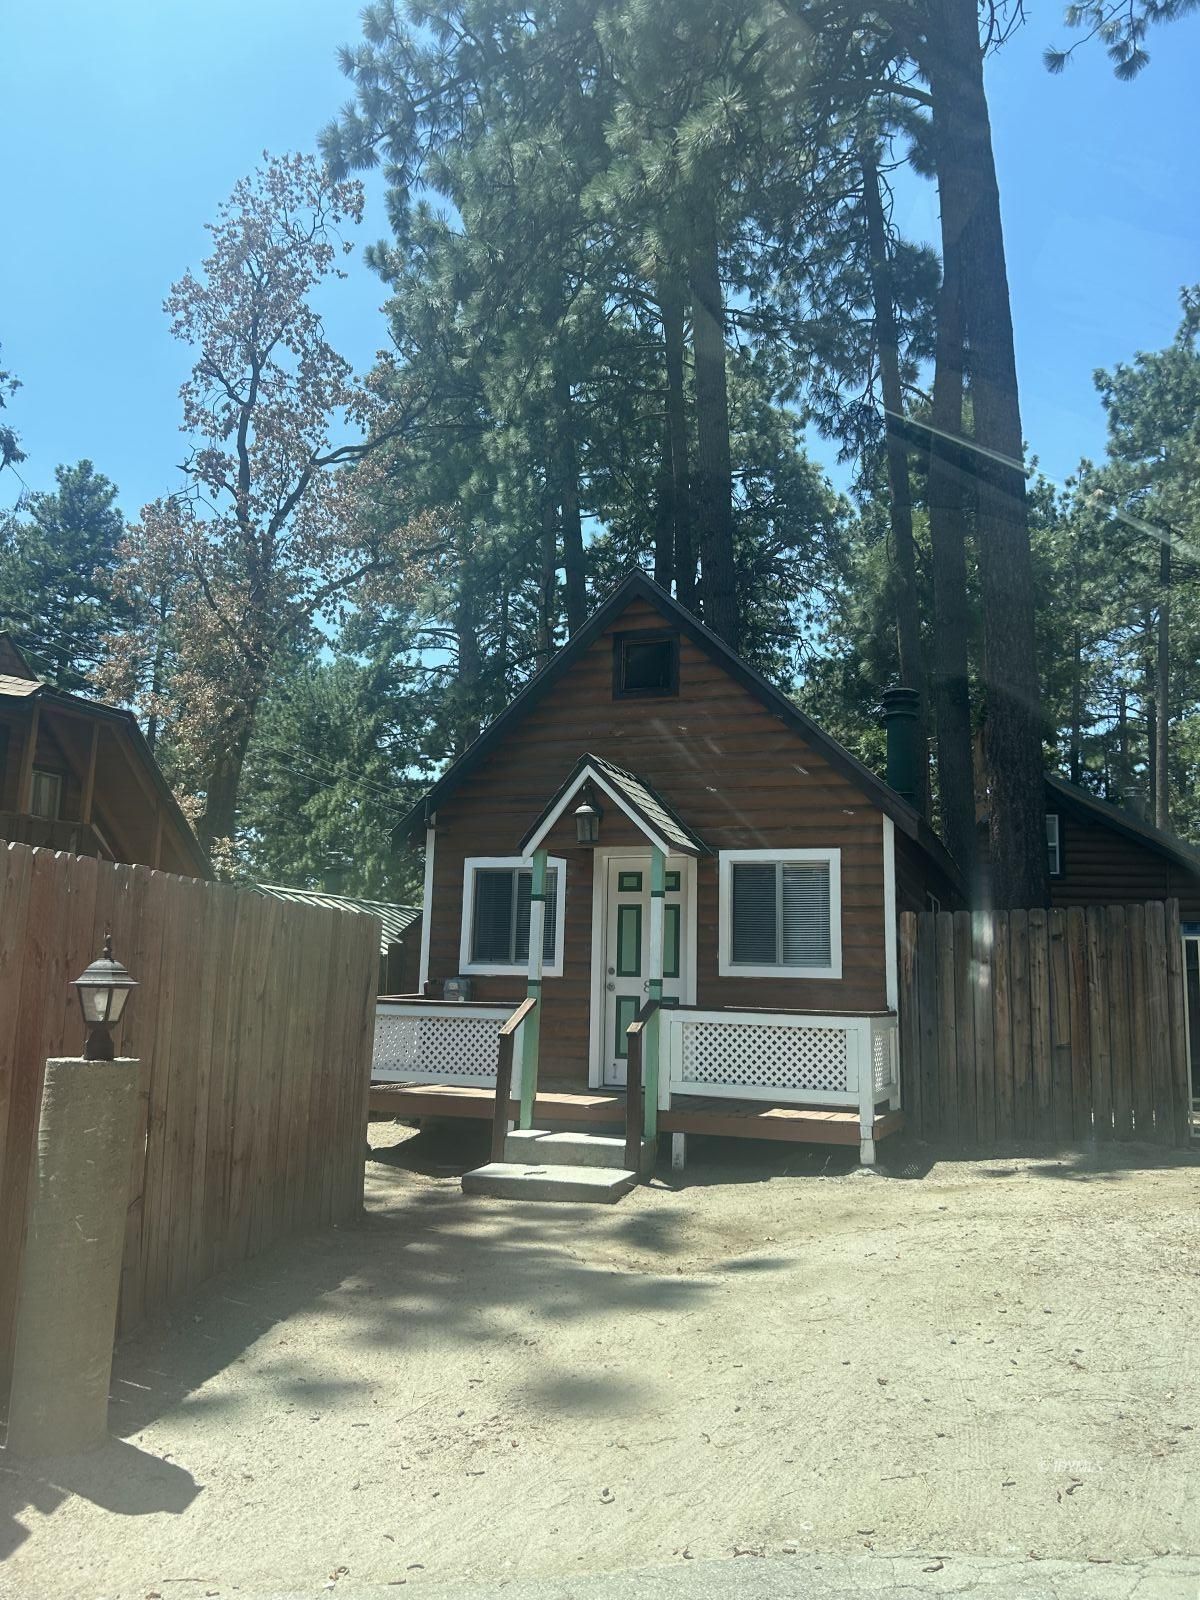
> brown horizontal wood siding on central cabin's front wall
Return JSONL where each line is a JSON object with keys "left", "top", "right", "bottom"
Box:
{"left": 429, "top": 600, "right": 886, "bottom": 1080}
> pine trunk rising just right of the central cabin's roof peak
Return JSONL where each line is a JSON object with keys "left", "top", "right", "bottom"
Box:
{"left": 690, "top": 200, "right": 738, "bottom": 650}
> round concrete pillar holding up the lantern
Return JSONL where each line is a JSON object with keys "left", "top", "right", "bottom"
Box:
{"left": 8, "top": 1059, "right": 139, "bottom": 1456}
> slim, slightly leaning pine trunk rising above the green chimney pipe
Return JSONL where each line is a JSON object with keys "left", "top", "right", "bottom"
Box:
{"left": 862, "top": 146, "right": 930, "bottom": 813}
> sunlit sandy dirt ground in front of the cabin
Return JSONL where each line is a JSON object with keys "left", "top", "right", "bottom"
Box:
{"left": 0, "top": 1123, "right": 1200, "bottom": 1600}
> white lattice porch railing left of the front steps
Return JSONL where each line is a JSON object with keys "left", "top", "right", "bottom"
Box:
{"left": 371, "top": 1000, "right": 522, "bottom": 1094}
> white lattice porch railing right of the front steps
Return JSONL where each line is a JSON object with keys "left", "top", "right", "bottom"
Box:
{"left": 659, "top": 1008, "right": 899, "bottom": 1107}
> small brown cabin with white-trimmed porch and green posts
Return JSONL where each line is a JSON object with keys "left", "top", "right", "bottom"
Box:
{"left": 374, "top": 573, "right": 962, "bottom": 1162}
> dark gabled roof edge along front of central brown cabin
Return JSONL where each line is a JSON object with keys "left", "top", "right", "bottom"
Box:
{"left": 397, "top": 570, "right": 962, "bottom": 886}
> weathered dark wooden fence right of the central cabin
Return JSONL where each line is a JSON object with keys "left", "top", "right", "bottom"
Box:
{"left": 899, "top": 901, "right": 1192, "bottom": 1146}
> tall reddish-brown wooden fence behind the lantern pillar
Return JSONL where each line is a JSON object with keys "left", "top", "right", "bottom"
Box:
{"left": 0, "top": 845, "right": 379, "bottom": 1402}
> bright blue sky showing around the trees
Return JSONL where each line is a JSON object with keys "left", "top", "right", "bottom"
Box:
{"left": 0, "top": 0, "right": 1200, "bottom": 515}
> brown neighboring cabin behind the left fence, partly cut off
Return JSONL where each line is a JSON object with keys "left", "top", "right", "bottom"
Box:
{"left": 0, "top": 635, "right": 211, "bottom": 878}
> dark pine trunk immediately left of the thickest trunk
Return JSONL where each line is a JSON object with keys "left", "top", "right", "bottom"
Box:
{"left": 928, "top": 112, "right": 979, "bottom": 901}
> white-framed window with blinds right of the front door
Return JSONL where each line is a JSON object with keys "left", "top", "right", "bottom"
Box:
{"left": 720, "top": 850, "right": 842, "bottom": 978}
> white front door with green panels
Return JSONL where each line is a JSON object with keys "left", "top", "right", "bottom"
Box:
{"left": 597, "top": 853, "right": 693, "bottom": 1088}
